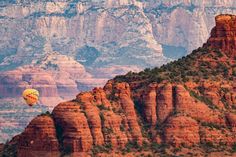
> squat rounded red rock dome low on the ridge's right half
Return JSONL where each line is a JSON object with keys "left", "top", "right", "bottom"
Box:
{"left": 164, "top": 116, "right": 200, "bottom": 147}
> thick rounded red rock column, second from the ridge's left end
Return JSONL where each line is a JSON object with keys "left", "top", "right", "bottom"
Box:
{"left": 52, "top": 102, "right": 93, "bottom": 152}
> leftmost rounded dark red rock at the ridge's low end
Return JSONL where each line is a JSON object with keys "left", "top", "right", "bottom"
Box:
{"left": 17, "top": 116, "right": 59, "bottom": 157}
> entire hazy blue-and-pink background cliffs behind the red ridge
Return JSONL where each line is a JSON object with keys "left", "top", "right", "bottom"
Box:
{"left": 0, "top": 0, "right": 236, "bottom": 141}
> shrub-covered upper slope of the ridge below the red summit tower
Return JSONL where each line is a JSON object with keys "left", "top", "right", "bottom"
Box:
{"left": 115, "top": 47, "right": 232, "bottom": 87}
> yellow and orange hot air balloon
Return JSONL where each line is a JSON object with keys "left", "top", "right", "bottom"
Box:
{"left": 22, "top": 89, "right": 39, "bottom": 106}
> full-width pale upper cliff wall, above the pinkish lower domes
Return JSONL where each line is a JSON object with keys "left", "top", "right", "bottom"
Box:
{"left": 0, "top": 0, "right": 236, "bottom": 69}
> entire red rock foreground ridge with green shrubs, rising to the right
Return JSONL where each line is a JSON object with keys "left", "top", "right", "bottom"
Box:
{"left": 4, "top": 15, "right": 236, "bottom": 157}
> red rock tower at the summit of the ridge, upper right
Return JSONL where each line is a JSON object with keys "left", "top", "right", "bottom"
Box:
{"left": 207, "top": 15, "right": 236, "bottom": 58}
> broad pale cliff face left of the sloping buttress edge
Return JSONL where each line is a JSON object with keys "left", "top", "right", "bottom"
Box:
{"left": 1, "top": 1, "right": 166, "bottom": 70}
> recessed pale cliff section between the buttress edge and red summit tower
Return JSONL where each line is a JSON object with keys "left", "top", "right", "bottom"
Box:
{"left": 144, "top": 0, "right": 236, "bottom": 56}
